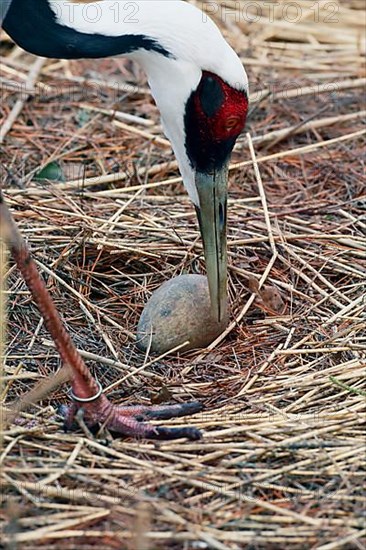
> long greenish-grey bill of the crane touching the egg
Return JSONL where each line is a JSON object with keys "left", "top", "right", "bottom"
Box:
{"left": 195, "top": 164, "right": 228, "bottom": 323}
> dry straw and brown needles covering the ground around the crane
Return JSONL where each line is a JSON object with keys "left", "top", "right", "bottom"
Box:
{"left": 0, "top": 0, "right": 366, "bottom": 550}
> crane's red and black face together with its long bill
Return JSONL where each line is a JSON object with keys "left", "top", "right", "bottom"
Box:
{"left": 184, "top": 71, "right": 248, "bottom": 322}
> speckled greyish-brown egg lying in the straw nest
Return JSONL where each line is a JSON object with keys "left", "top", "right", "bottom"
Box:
{"left": 137, "top": 275, "right": 227, "bottom": 353}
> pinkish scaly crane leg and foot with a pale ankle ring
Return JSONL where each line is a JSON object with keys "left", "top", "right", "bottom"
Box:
{"left": 0, "top": 191, "right": 203, "bottom": 440}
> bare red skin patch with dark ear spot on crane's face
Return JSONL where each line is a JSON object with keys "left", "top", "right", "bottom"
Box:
{"left": 194, "top": 71, "right": 248, "bottom": 142}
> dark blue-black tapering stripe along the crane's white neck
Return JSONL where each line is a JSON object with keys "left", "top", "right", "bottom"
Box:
{"left": 0, "top": 0, "right": 174, "bottom": 59}
